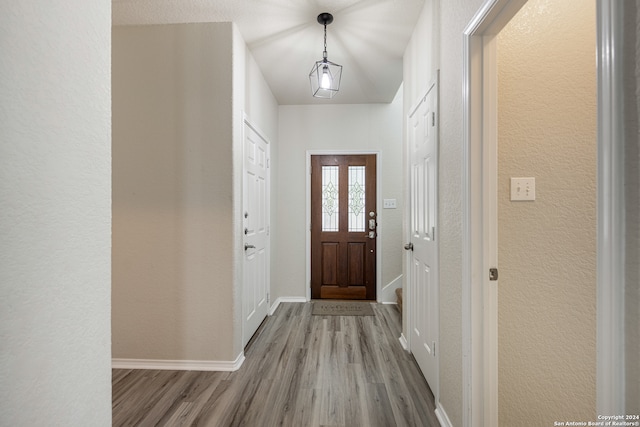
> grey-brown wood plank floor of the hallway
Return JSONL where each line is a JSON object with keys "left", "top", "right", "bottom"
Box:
{"left": 112, "top": 303, "right": 439, "bottom": 427}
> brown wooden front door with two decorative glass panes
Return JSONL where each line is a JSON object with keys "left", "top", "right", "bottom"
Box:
{"left": 311, "top": 154, "right": 377, "bottom": 300}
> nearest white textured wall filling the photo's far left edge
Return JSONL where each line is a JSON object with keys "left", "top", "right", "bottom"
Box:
{"left": 0, "top": 0, "right": 111, "bottom": 426}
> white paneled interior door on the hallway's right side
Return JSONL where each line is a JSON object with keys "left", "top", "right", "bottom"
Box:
{"left": 407, "top": 82, "right": 438, "bottom": 396}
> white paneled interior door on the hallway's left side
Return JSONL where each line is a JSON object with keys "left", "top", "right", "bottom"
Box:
{"left": 242, "top": 121, "right": 270, "bottom": 346}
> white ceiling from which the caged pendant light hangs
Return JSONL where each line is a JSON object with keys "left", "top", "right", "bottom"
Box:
{"left": 113, "top": 0, "right": 424, "bottom": 105}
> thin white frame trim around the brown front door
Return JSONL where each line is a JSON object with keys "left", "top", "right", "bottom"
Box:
{"left": 305, "top": 150, "right": 384, "bottom": 301}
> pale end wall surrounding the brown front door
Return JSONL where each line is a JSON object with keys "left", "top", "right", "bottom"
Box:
{"left": 272, "top": 92, "right": 403, "bottom": 301}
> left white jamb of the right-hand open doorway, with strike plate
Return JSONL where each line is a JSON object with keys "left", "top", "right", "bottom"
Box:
{"left": 462, "top": 0, "right": 526, "bottom": 426}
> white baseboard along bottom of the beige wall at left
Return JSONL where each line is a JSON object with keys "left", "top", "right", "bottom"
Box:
{"left": 111, "top": 353, "right": 244, "bottom": 371}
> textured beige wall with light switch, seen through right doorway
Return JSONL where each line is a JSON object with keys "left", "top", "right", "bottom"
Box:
{"left": 498, "top": 0, "right": 596, "bottom": 426}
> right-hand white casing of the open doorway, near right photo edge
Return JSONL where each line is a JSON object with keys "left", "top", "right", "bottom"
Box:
{"left": 596, "top": 0, "right": 637, "bottom": 414}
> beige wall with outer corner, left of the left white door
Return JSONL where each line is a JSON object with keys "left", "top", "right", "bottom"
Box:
{"left": 113, "top": 23, "right": 277, "bottom": 362}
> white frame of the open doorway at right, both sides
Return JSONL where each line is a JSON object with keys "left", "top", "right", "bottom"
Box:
{"left": 461, "top": 0, "right": 625, "bottom": 426}
